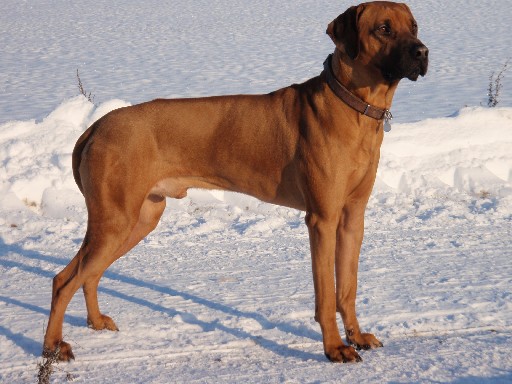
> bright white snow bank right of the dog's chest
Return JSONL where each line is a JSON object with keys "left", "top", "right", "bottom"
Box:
{"left": 376, "top": 107, "right": 512, "bottom": 197}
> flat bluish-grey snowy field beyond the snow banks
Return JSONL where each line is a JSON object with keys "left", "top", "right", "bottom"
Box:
{"left": 0, "top": 0, "right": 512, "bottom": 123}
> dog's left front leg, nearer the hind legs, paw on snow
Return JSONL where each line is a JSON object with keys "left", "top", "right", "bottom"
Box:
{"left": 306, "top": 212, "right": 361, "bottom": 363}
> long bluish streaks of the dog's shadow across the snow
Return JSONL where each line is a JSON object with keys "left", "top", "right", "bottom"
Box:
{"left": 0, "top": 238, "right": 325, "bottom": 362}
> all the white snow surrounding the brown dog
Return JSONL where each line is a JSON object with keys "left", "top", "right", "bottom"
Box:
{"left": 0, "top": 0, "right": 512, "bottom": 383}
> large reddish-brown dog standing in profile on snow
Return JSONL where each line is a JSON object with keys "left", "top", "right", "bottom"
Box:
{"left": 43, "top": 1, "right": 428, "bottom": 362}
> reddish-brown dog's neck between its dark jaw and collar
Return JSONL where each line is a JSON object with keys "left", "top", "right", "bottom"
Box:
{"left": 331, "top": 49, "right": 398, "bottom": 110}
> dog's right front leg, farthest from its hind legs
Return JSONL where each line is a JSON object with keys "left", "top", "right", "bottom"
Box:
{"left": 336, "top": 201, "right": 382, "bottom": 349}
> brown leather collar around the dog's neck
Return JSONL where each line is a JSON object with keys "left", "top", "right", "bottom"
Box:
{"left": 324, "top": 54, "right": 393, "bottom": 122}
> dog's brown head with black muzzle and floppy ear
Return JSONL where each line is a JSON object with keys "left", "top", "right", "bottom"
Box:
{"left": 327, "top": 1, "right": 428, "bottom": 82}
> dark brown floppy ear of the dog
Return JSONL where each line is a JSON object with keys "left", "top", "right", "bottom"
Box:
{"left": 326, "top": 5, "right": 364, "bottom": 60}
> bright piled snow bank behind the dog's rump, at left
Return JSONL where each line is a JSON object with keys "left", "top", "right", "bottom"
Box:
{"left": 0, "top": 96, "right": 129, "bottom": 217}
